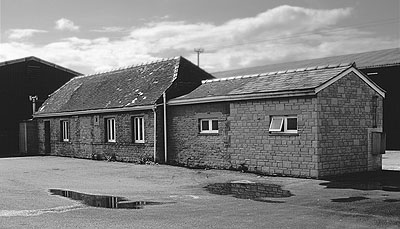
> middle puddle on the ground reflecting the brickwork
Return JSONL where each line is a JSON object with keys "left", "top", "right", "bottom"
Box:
{"left": 205, "top": 182, "right": 293, "bottom": 203}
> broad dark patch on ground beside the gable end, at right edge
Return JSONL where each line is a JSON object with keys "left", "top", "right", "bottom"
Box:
{"left": 320, "top": 170, "right": 400, "bottom": 192}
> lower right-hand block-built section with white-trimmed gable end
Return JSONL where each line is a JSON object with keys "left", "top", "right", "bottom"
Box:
{"left": 168, "top": 64, "right": 385, "bottom": 178}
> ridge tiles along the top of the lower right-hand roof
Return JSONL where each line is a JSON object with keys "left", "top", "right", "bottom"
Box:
{"left": 205, "top": 62, "right": 355, "bottom": 84}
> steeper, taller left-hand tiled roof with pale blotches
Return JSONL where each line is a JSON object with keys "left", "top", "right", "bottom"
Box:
{"left": 35, "top": 57, "right": 183, "bottom": 117}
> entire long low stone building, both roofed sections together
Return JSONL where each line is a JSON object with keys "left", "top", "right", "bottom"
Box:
{"left": 34, "top": 57, "right": 385, "bottom": 178}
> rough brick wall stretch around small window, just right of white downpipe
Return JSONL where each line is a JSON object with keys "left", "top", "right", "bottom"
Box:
{"left": 168, "top": 103, "right": 230, "bottom": 168}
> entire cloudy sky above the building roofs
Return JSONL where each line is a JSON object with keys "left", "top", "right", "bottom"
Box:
{"left": 0, "top": 0, "right": 400, "bottom": 74}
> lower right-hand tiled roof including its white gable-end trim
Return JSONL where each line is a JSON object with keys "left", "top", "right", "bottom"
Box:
{"left": 169, "top": 64, "right": 384, "bottom": 105}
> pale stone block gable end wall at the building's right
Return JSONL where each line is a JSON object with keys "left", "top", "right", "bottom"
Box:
{"left": 317, "top": 73, "right": 383, "bottom": 177}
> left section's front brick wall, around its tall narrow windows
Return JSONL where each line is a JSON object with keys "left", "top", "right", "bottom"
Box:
{"left": 38, "top": 110, "right": 154, "bottom": 162}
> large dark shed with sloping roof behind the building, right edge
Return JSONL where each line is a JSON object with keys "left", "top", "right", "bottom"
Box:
{"left": 212, "top": 48, "right": 400, "bottom": 150}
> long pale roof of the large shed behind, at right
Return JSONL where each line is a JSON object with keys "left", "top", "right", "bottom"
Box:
{"left": 212, "top": 48, "right": 400, "bottom": 78}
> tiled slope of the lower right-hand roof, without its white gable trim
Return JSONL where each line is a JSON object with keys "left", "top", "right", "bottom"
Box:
{"left": 171, "top": 64, "right": 353, "bottom": 104}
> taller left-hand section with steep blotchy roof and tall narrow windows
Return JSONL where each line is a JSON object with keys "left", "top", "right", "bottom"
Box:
{"left": 34, "top": 57, "right": 213, "bottom": 162}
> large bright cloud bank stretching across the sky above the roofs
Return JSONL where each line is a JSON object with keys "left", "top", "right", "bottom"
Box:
{"left": 0, "top": 6, "right": 398, "bottom": 73}
